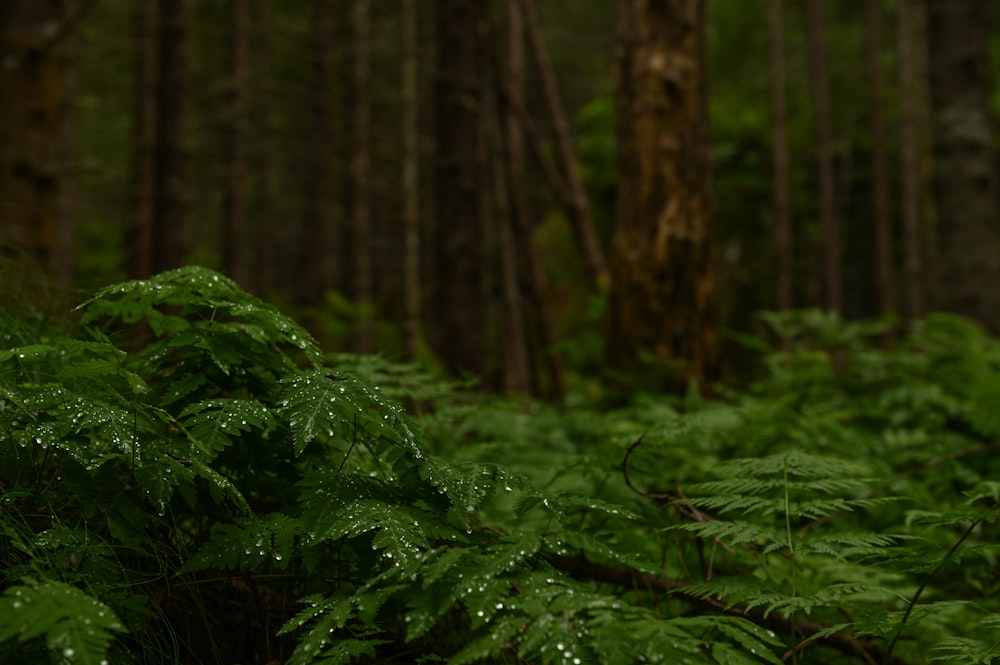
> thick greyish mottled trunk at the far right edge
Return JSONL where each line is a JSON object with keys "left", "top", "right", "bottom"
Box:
{"left": 927, "top": 0, "right": 1000, "bottom": 333}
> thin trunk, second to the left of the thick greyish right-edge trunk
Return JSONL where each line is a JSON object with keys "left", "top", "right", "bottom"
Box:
{"left": 866, "top": 0, "right": 898, "bottom": 332}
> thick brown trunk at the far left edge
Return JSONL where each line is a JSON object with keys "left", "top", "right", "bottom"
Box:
{"left": 0, "top": 0, "right": 75, "bottom": 281}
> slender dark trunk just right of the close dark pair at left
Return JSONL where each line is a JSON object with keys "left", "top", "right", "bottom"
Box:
{"left": 223, "top": 0, "right": 250, "bottom": 288}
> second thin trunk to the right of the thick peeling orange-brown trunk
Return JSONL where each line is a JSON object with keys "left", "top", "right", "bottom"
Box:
{"left": 806, "top": 0, "right": 843, "bottom": 313}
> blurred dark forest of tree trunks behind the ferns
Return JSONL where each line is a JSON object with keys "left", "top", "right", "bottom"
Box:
{"left": 0, "top": 0, "right": 1000, "bottom": 395}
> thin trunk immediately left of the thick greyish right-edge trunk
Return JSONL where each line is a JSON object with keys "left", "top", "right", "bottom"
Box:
{"left": 898, "top": 0, "right": 926, "bottom": 321}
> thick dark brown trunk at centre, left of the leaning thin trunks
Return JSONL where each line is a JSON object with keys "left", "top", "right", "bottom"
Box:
{"left": 426, "top": 0, "right": 489, "bottom": 376}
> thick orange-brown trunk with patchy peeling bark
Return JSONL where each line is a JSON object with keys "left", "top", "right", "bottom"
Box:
{"left": 607, "top": 0, "right": 717, "bottom": 383}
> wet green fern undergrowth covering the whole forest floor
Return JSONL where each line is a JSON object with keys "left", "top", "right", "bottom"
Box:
{"left": 0, "top": 268, "right": 1000, "bottom": 665}
